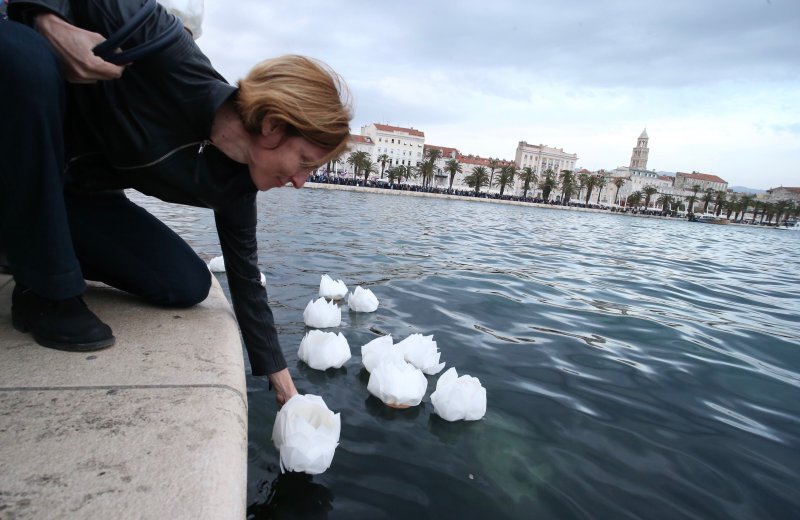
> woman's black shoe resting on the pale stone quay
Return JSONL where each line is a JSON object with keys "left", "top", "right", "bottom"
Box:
{"left": 11, "top": 284, "right": 114, "bottom": 352}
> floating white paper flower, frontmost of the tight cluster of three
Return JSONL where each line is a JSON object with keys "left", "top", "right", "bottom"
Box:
{"left": 367, "top": 348, "right": 428, "bottom": 408}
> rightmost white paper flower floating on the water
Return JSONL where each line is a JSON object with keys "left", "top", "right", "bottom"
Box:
{"left": 431, "top": 367, "right": 486, "bottom": 421}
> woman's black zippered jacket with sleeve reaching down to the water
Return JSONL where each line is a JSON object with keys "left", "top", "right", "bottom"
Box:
{"left": 9, "top": 0, "right": 286, "bottom": 375}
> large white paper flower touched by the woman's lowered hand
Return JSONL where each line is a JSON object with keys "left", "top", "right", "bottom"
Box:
{"left": 272, "top": 394, "right": 342, "bottom": 475}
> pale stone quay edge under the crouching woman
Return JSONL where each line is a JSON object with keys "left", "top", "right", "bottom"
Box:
{"left": 0, "top": 274, "right": 247, "bottom": 520}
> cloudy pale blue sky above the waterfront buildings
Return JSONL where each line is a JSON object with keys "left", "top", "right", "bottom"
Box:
{"left": 197, "top": 0, "right": 800, "bottom": 189}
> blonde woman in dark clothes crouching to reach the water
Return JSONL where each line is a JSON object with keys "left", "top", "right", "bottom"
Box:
{"left": 0, "top": 0, "right": 352, "bottom": 404}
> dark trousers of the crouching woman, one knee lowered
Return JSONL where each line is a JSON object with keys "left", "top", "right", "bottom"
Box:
{"left": 0, "top": 21, "right": 211, "bottom": 306}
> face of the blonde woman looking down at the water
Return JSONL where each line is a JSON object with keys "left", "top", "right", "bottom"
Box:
{"left": 248, "top": 134, "right": 328, "bottom": 191}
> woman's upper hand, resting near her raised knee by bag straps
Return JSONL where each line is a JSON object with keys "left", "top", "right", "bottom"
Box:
{"left": 35, "top": 13, "right": 125, "bottom": 83}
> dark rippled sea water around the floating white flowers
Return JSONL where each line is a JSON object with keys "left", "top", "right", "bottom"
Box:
{"left": 131, "top": 189, "right": 800, "bottom": 519}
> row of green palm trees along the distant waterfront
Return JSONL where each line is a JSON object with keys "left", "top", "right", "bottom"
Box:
{"left": 346, "top": 148, "right": 800, "bottom": 223}
